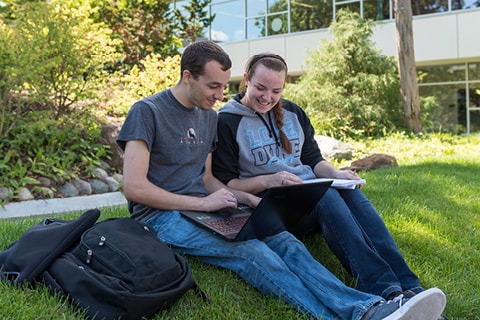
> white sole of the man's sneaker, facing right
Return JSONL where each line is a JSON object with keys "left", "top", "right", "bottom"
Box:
{"left": 383, "top": 288, "right": 447, "bottom": 320}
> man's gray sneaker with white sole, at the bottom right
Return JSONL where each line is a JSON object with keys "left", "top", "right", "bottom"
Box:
{"left": 364, "top": 288, "right": 446, "bottom": 320}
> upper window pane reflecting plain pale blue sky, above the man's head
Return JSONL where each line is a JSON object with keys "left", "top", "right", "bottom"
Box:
{"left": 210, "top": 0, "right": 245, "bottom": 42}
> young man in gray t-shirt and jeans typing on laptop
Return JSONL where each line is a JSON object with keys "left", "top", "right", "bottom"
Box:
{"left": 117, "top": 41, "right": 445, "bottom": 320}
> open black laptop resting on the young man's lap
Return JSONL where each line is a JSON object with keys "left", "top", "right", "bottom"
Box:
{"left": 180, "top": 180, "right": 332, "bottom": 241}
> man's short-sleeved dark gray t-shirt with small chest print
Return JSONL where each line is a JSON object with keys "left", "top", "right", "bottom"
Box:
{"left": 117, "top": 89, "right": 217, "bottom": 220}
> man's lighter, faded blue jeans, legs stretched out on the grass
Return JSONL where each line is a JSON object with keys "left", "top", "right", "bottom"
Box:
{"left": 146, "top": 211, "right": 382, "bottom": 320}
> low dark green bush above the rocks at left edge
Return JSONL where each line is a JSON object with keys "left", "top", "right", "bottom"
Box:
{"left": 0, "top": 111, "right": 109, "bottom": 197}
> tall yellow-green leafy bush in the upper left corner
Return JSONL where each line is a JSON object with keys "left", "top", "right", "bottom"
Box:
{"left": 6, "top": 1, "right": 120, "bottom": 117}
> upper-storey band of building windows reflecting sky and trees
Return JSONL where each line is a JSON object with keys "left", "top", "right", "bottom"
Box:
{"left": 202, "top": 0, "right": 480, "bottom": 42}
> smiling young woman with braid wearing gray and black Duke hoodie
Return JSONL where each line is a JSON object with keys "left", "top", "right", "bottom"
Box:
{"left": 212, "top": 53, "right": 444, "bottom": 300}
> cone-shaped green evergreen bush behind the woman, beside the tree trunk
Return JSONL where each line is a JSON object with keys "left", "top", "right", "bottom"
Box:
{"left": 284, "top": 10, "right": 402, "bottom": 138}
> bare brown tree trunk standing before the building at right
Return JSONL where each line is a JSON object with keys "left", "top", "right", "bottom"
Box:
{"left": 394, "top": 0, "right": 422, "bottom": 133}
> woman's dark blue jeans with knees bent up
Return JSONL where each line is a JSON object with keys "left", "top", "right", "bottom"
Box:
{"left": 295, "top": 188, "right": 423, "bottom": 298}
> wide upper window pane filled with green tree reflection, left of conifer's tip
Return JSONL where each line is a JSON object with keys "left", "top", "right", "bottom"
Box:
{"left": 290, "top": 0, "right": 333, "bottom": 32}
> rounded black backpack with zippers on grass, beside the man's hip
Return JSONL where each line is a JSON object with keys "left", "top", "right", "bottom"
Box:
{"left": 0, "top": 210, "right": 209, "bottom": 320}
